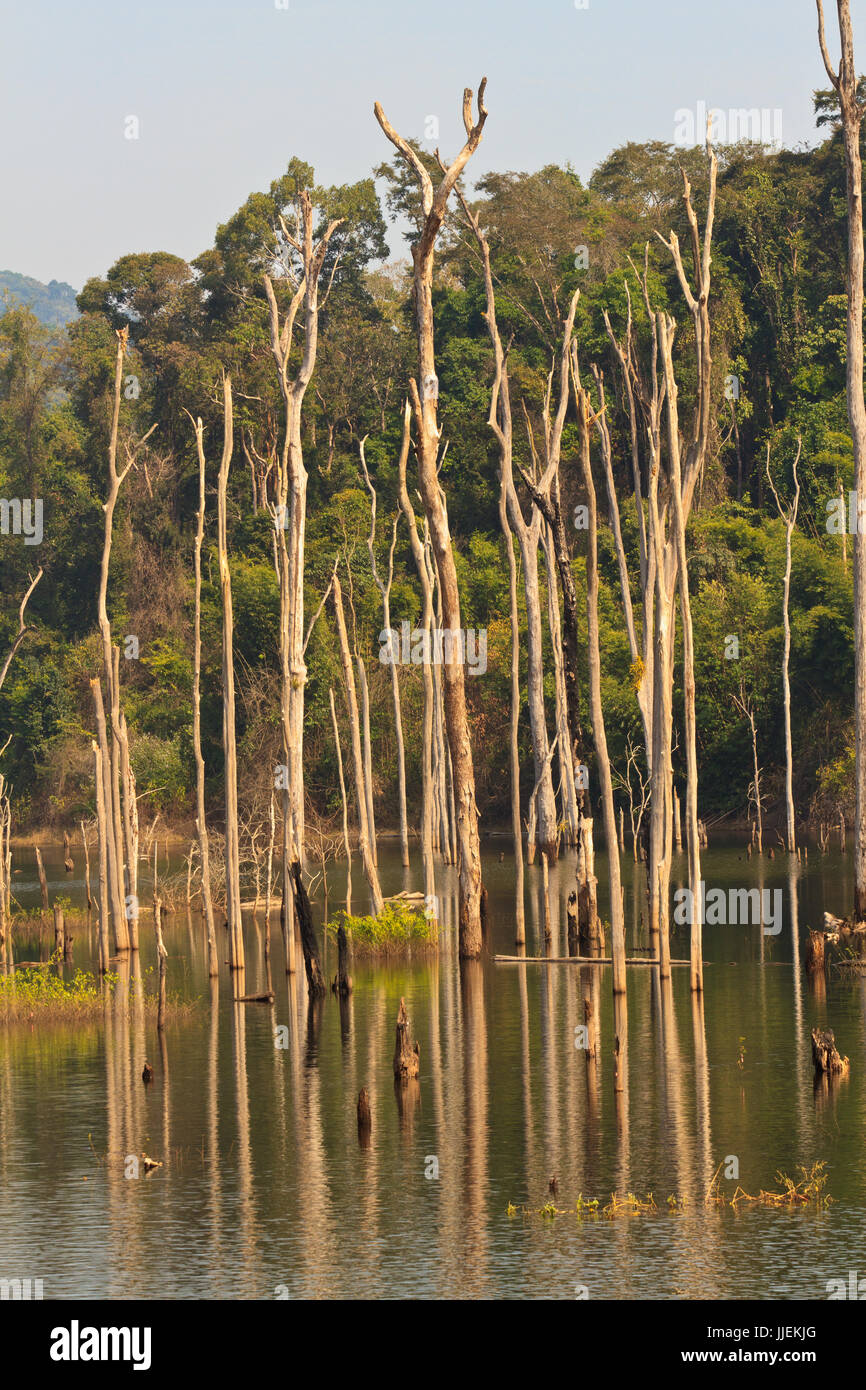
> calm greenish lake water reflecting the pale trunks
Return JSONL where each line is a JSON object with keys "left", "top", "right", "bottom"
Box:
{"left": 0, "top": 841, "right": 866, "bottom": 1300}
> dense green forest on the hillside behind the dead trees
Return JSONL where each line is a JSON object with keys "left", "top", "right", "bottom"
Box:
{"left": 0, "top": 93, "right": 855, "bottom": 833}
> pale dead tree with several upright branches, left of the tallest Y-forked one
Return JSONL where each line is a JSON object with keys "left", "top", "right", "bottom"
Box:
{"left": 264, "top": 189, "right": 341, "bottom": 923}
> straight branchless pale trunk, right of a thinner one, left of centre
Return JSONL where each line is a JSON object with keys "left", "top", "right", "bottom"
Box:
{"left": 217, "top": 375, "right": 245, "bottom": 970}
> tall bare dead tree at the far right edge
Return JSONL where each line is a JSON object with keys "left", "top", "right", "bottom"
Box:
{"left": 817, "top": 0, "right": 866, "bottom": 923}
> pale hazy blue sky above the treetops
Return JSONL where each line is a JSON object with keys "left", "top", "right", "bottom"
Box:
{"left": 0, "top": 0, "right": 866, "bottom": 289}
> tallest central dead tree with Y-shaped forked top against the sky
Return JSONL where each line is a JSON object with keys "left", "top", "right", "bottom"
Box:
{"left": 374, "top": 78, "right": 487, "bottom": 958}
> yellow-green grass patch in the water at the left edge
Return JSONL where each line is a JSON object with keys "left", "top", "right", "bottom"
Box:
{"left": 0, "top": 962, "right": 192, "bottom": 1023}
